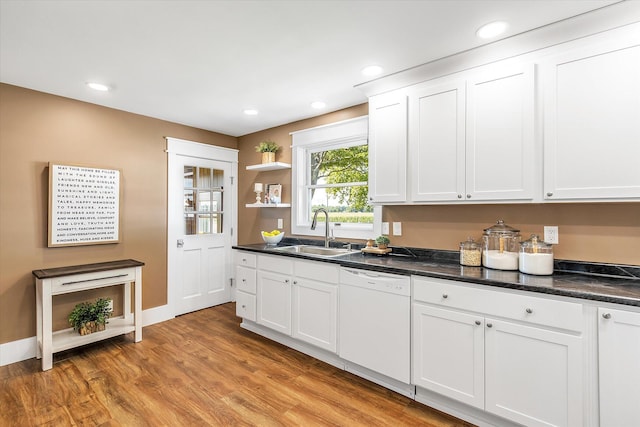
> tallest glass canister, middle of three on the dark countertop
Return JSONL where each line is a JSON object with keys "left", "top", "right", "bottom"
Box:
{"left": 482, "top": 220, "right": 520, "bottom": 270}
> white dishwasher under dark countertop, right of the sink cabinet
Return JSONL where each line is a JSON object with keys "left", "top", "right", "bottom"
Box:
{"left": 338, "top": 267, "right": 411, "bottom": 384}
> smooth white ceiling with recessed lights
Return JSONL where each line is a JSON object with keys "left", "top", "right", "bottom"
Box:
{"left": 0, "top": 0, "right": 617, "bottom": 136}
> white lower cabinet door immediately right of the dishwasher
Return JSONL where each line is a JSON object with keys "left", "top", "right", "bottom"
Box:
{"left": 413, "top": 304, "right": 484, "bottom": 409}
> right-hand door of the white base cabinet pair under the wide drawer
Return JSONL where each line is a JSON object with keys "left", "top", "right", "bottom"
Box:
{"left": 485, "top": 318, "right": 583, "bottom": 426}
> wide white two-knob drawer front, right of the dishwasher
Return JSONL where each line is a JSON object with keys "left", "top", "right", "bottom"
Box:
{"left": 413, "top": 277, "right": 583, "bottom": 332}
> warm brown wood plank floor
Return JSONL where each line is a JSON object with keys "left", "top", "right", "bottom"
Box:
{"left": 0, "top": 303, "right": 470, "bottom": 427}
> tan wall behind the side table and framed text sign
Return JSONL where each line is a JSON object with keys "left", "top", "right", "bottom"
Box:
{"left": 0, "top": 84, "right": 237, "bottom": 343}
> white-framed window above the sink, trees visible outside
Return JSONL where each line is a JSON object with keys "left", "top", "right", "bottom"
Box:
{"left": 291, "top": 117, "right": 380, "bottom": 239}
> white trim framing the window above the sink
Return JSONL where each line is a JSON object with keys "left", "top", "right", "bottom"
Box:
{"left": 290, "top": 116, "right": 382, "bottom": 239}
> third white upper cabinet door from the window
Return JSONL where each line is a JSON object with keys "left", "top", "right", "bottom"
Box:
{"left": 465, "top": 64, "right": 537, "bottom": 201}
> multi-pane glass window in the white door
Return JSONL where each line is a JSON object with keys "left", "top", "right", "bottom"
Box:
{"left": 184, "top": 166, "right": 224, "bottom": 234}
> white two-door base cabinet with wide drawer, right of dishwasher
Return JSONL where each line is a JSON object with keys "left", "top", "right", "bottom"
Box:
{"left": 413, "top": 277, "right": 583, "bottom": 426}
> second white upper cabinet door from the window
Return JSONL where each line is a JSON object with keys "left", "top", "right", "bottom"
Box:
{"left": 409, "top": 80, "right": 465, "bottom": 202}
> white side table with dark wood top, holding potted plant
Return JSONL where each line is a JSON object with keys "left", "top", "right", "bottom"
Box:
{"left": 32, "top": 259, "right": 144, "bottom": 371}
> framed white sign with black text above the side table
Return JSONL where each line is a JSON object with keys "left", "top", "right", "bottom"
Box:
{"left": 48, "top": 163, "right": 121, "bottom": 247}
